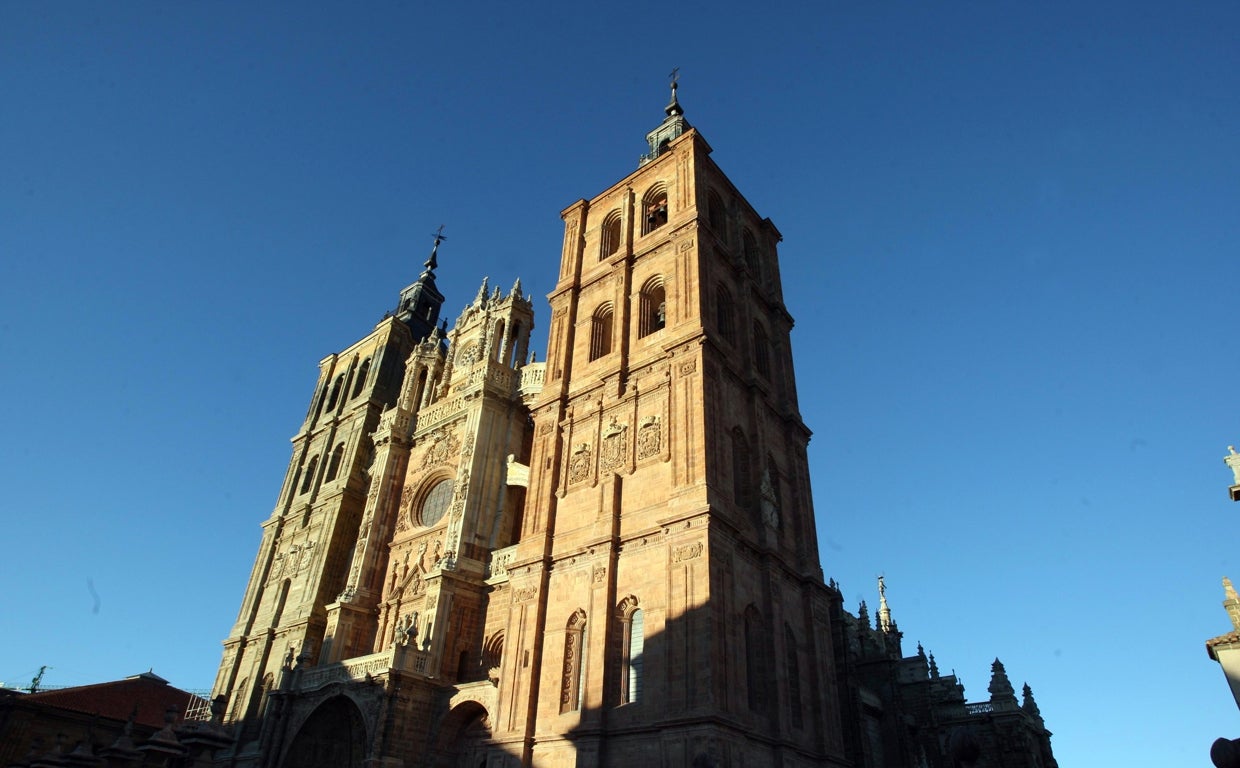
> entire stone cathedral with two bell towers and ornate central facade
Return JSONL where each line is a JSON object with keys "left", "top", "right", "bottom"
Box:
{"left": 203, "top": 83, "right": 1055, "bottom": 768}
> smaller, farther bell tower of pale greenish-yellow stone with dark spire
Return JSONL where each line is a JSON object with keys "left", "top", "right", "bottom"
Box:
{"left": 213, "top": 236, "right": 444, "bottom": 751}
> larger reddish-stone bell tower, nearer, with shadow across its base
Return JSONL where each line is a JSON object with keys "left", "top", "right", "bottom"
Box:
{"left": 491, "top": 83, "right": 842, "bottom": 767}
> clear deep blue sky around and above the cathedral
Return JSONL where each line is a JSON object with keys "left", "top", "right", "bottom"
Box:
{"left": 0, "top": 0, "right": 1240, "bottom": 768}
